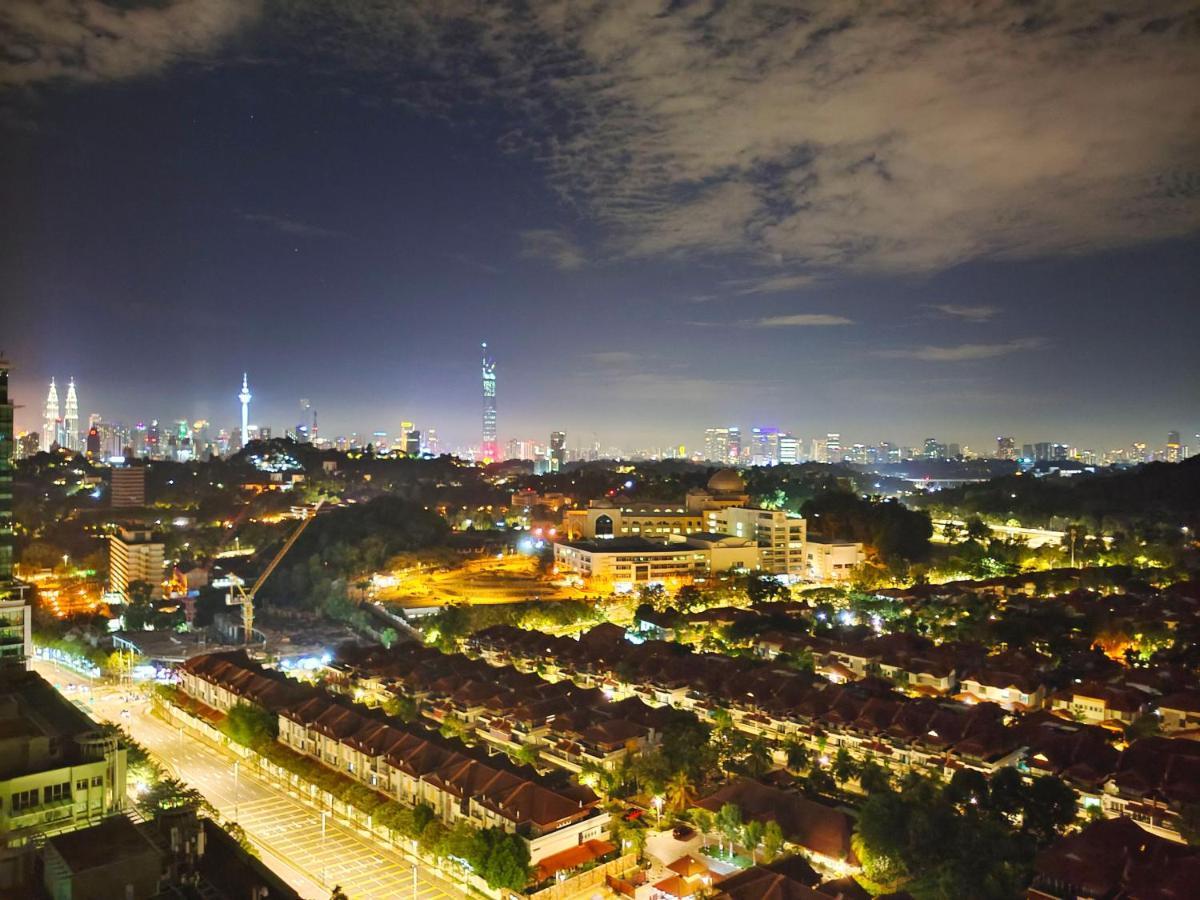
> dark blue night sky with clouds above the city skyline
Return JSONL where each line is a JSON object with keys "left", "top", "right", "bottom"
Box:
{"left": 0, "top": 0, "right": 1200, "bottom": 450}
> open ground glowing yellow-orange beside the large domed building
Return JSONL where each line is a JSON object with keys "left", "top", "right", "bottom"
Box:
{"left": 376, "top": 556, "right": 588, "bottom": 606}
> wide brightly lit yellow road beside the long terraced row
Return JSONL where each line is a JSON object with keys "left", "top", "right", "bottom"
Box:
{"left": 35, "top": 661, "right": 462, "bottom": 900}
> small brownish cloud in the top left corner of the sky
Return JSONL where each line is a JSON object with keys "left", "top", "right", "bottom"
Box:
{"left": 0, "top": 0, "right": 262, "bottom": 86}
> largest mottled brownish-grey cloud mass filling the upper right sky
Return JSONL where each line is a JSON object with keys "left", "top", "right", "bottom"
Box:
{"left": 295, "top": 0, "right": 1200, "bottom": 271}
